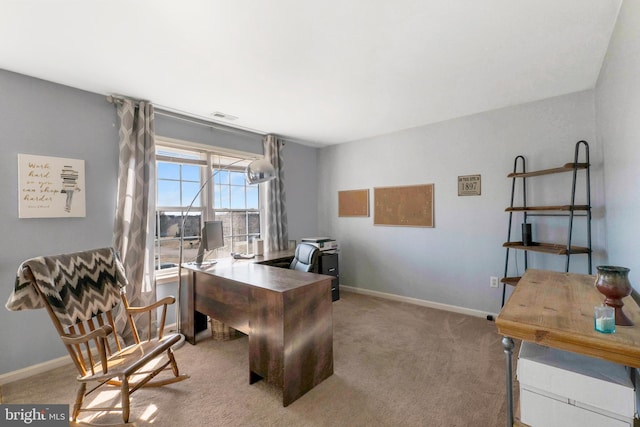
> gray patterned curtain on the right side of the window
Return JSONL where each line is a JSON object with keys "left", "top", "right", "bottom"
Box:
{"left": 263, "top": 135, "right": 289, "bottom": 251}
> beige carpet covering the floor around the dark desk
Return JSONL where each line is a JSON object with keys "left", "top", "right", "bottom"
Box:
{"left": 2, "top": 292, "right": 506, "bottom": 427}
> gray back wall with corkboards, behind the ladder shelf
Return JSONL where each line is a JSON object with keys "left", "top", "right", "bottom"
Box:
{"left": 318, "top": 91, "right": 604, "bottom": 313}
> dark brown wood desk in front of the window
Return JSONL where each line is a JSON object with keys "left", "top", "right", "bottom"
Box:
{"left": 180, "top": 253, "right": 333, "bottom": 406}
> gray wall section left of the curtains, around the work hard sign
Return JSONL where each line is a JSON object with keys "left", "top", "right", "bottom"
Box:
{"left": 0, "top": 70, "right": 118, "bottom": 373}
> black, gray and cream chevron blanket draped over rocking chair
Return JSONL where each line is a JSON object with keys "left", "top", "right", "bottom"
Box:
{"left": 5, "top": 248, "right": 127, "bottom": 326}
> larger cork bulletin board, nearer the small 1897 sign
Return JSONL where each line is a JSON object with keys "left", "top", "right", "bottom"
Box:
{"left": 373, "top": 184, "right": 434, "bottom": 227}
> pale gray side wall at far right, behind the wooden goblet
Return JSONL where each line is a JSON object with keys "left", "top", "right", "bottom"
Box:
{"left": 596, "top": 1, "right": 640, "bottom": 289}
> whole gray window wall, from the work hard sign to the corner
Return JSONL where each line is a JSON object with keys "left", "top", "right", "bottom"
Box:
{"left": 0, "top": 70, "right": 318, "bottom": 374}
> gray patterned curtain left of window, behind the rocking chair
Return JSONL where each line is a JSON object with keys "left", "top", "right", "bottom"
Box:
{"left": 114, "top": 99, "right": 156, "bottom": 340}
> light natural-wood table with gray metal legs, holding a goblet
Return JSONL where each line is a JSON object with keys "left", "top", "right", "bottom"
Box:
{"left": 496, "top": 269, "right": 640, "bottom": 427}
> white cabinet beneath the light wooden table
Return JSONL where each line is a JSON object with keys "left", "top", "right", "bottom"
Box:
{"left": 517, "top": 342, "right": 636, "bottom": 427}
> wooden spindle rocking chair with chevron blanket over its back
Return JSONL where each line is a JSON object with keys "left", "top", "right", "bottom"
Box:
{"left": 6, "top": 248, "right": 189, "bottom": 423}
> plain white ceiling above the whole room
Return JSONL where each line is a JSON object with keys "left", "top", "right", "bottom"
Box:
{"left": 0, "top": 0, "right": 622, "bottom": 145}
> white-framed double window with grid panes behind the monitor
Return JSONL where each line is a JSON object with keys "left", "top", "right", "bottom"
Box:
{"left": 155, "top": 143, "right": 260, "bottom": 270}
